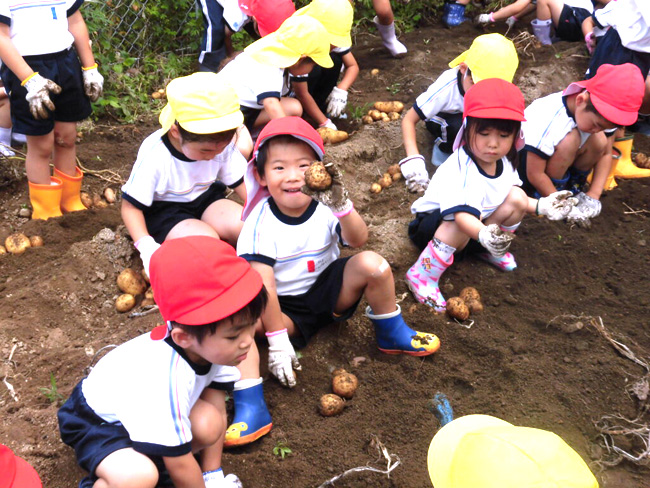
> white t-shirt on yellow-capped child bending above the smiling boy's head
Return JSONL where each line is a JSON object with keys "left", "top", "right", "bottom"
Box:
{"left": 218, "top": 53, "right": 286, "bottom": 109}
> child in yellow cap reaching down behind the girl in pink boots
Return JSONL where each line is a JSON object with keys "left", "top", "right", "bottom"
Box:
{"left": 399, "top": 34, "right": 519, "bottom": 192}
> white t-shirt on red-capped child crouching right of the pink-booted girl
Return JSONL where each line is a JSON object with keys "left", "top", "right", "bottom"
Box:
{"left": 521, "top": 92, "right": 591, "bottom": 159}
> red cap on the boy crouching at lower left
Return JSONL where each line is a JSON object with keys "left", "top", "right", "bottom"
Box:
{"left": 150, "top": 236, "right": 262, "bottom": 325}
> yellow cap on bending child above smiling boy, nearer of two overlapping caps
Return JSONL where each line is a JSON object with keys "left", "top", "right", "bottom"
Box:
{"left": 244, "top": 15, "right": 334, "bottom": 68}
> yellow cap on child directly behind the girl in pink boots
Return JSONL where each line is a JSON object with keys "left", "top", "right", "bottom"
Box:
{"left": 449, "top": 34, "right": 519, "bottom": 83}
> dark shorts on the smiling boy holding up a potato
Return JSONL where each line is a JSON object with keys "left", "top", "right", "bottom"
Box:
{"left": 278, "top": 257, "right": 361, "bottom": 348}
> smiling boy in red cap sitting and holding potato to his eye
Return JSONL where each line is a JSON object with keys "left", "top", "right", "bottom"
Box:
{"left": 237, "top": 117, "right": 440, "bottom": 392}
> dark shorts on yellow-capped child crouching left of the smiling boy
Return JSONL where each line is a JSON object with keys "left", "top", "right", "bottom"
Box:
{"left": 125, "top": 181, "right": 226, "bottom": 244}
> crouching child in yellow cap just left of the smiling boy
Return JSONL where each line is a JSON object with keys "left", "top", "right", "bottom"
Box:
{"left": 122, "top": 72, "right": 252, "bottom": 274}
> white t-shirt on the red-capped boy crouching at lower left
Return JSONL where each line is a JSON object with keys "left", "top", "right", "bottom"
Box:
{"left": 81, "top": 333, "right": 241, "bottom": 456}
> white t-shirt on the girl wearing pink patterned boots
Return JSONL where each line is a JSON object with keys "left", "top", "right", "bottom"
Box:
{"left": 411, "top": 146, "right": 522, "bottom": 220}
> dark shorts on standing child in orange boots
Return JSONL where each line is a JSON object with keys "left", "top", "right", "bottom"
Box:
{"left": 0, "top": 48, "right": 92, "bottom": 136}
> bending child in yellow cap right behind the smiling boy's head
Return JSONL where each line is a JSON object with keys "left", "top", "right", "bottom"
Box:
{"left": 219, "top": 15, "right": 333, "bottom": 133}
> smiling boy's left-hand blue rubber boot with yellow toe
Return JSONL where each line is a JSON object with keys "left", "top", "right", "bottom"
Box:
{"left": 223, "top": 378, "right": 273, "bottom": 447}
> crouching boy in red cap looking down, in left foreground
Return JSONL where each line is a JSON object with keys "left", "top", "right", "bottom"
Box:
{"left": 58, "top": 236, "right": 267, "bottom": 488}
